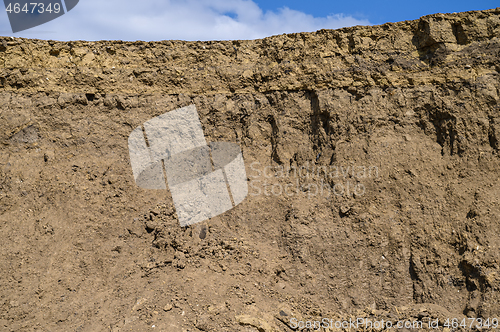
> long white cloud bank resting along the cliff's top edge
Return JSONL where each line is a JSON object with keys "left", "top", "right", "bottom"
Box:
{"left": 0, "top": 0, "right": 370, "bottom": 41}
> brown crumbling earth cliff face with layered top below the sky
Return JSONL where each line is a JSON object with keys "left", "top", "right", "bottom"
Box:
{"left": 0, "top": 8, "right": 500, "bottom": 332}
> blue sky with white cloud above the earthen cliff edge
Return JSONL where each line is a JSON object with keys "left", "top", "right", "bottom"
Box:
{"left": 0, "top": 0, "right": 500, "bottom": 41}
